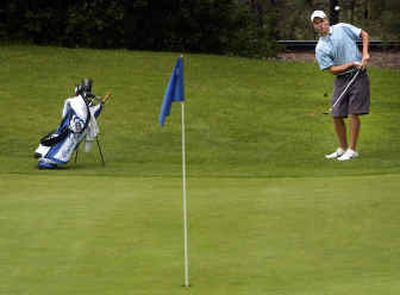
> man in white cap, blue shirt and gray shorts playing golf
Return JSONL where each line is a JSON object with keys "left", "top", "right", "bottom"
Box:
{"left": 311, "top": 10, "right": 370, "bottom": 161}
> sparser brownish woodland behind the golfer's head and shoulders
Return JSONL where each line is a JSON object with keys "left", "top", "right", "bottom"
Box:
{"left": 274, "top": 0, "right": 400, "bottom": 40}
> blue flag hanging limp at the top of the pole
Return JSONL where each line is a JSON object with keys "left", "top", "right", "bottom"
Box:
{"left": 160, "top": 56, "right": 185, "bottom": 126}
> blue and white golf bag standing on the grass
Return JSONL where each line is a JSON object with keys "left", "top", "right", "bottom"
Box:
{"left": 35, "top": 80, "right": 104, "bottom": 169}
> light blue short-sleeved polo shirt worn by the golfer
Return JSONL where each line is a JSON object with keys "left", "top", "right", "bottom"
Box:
{"left": 315, "top": 23, "right": 362, "bottom": 71}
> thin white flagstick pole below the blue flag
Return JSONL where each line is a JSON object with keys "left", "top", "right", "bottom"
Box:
{"left": 181, "top": 102, "right": 189, "bottom": 288}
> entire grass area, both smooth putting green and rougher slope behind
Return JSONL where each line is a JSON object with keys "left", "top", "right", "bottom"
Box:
{"left": 0, "top": 46, "right": 400, "bottom": 295}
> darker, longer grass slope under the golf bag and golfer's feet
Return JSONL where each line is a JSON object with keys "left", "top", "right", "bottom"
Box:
{"left": 0, "top": 46, "right": 400, "bottom": 177}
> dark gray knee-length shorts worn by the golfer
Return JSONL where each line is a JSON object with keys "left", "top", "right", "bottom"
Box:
{"left": 332, "top": 71, "right": 370, "bottom": 118}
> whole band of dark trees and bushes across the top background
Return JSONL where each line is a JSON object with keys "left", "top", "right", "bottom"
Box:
{"left": 0, "top": 0, "right": 400, "bottom": 57}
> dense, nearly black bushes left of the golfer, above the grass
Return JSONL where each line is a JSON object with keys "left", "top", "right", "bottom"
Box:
{"left": 0, "top": 0, "right": 275, "bottom": 57}
